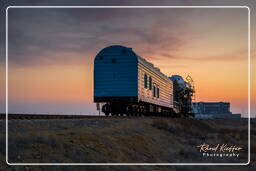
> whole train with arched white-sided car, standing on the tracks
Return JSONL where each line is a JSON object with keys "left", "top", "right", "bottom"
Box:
{"left": 94, "top": 45, "right": 195, "bottom": 117}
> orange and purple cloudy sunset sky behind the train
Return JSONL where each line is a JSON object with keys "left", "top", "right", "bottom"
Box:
{"left": 1, "top": 0, "right": 255, "bottom": 116}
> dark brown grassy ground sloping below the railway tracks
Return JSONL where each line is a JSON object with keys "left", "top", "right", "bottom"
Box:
{"left": 0, "top": 117, "right": 256, "bottom": 170}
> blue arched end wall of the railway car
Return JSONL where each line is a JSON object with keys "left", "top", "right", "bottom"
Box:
{"left": 94, "top": 46, "right": 138, "bottom": 102}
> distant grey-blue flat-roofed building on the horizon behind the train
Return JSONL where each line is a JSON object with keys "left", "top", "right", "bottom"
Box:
{"left": 192, "top": 102, "right": 241, "bottom": 119}
